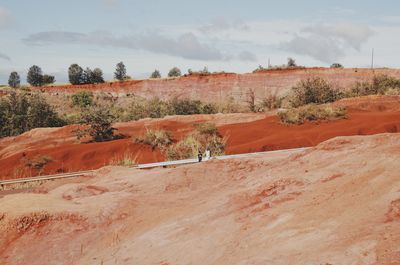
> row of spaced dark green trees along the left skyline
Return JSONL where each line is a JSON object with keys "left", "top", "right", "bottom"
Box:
{"left": 8, "top": 62, "right": 185, "bottom": 88}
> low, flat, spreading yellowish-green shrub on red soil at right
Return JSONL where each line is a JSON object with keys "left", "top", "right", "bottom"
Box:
{"left": 278, "top": 104, "right": 347, "bottom": 124}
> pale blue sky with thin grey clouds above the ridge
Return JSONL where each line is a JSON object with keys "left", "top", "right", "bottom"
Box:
{"left": 0, "top": 0, "right": 400, "bottom": 84}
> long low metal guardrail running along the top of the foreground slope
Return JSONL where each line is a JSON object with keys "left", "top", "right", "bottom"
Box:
{"left": 0, "top": 147, "right": 311, "bottom": 187}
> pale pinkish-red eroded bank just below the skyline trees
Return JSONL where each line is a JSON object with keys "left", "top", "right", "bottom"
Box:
{"left": 27, "top": 68, "right": 400, "bottom": 102}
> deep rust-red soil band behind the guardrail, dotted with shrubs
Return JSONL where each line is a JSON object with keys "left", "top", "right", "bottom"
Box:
{"left": 0, "top": 97, "right": 400, "bottom": 179}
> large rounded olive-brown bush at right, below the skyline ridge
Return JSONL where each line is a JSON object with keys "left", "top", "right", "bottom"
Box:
{"left": 290, "top": 77, "right": 339, "bottom": 107}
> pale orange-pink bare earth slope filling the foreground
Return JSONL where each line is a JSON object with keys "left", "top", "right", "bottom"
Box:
{"left": 0, "top": 134, "right": 400, "bottom": 265}
